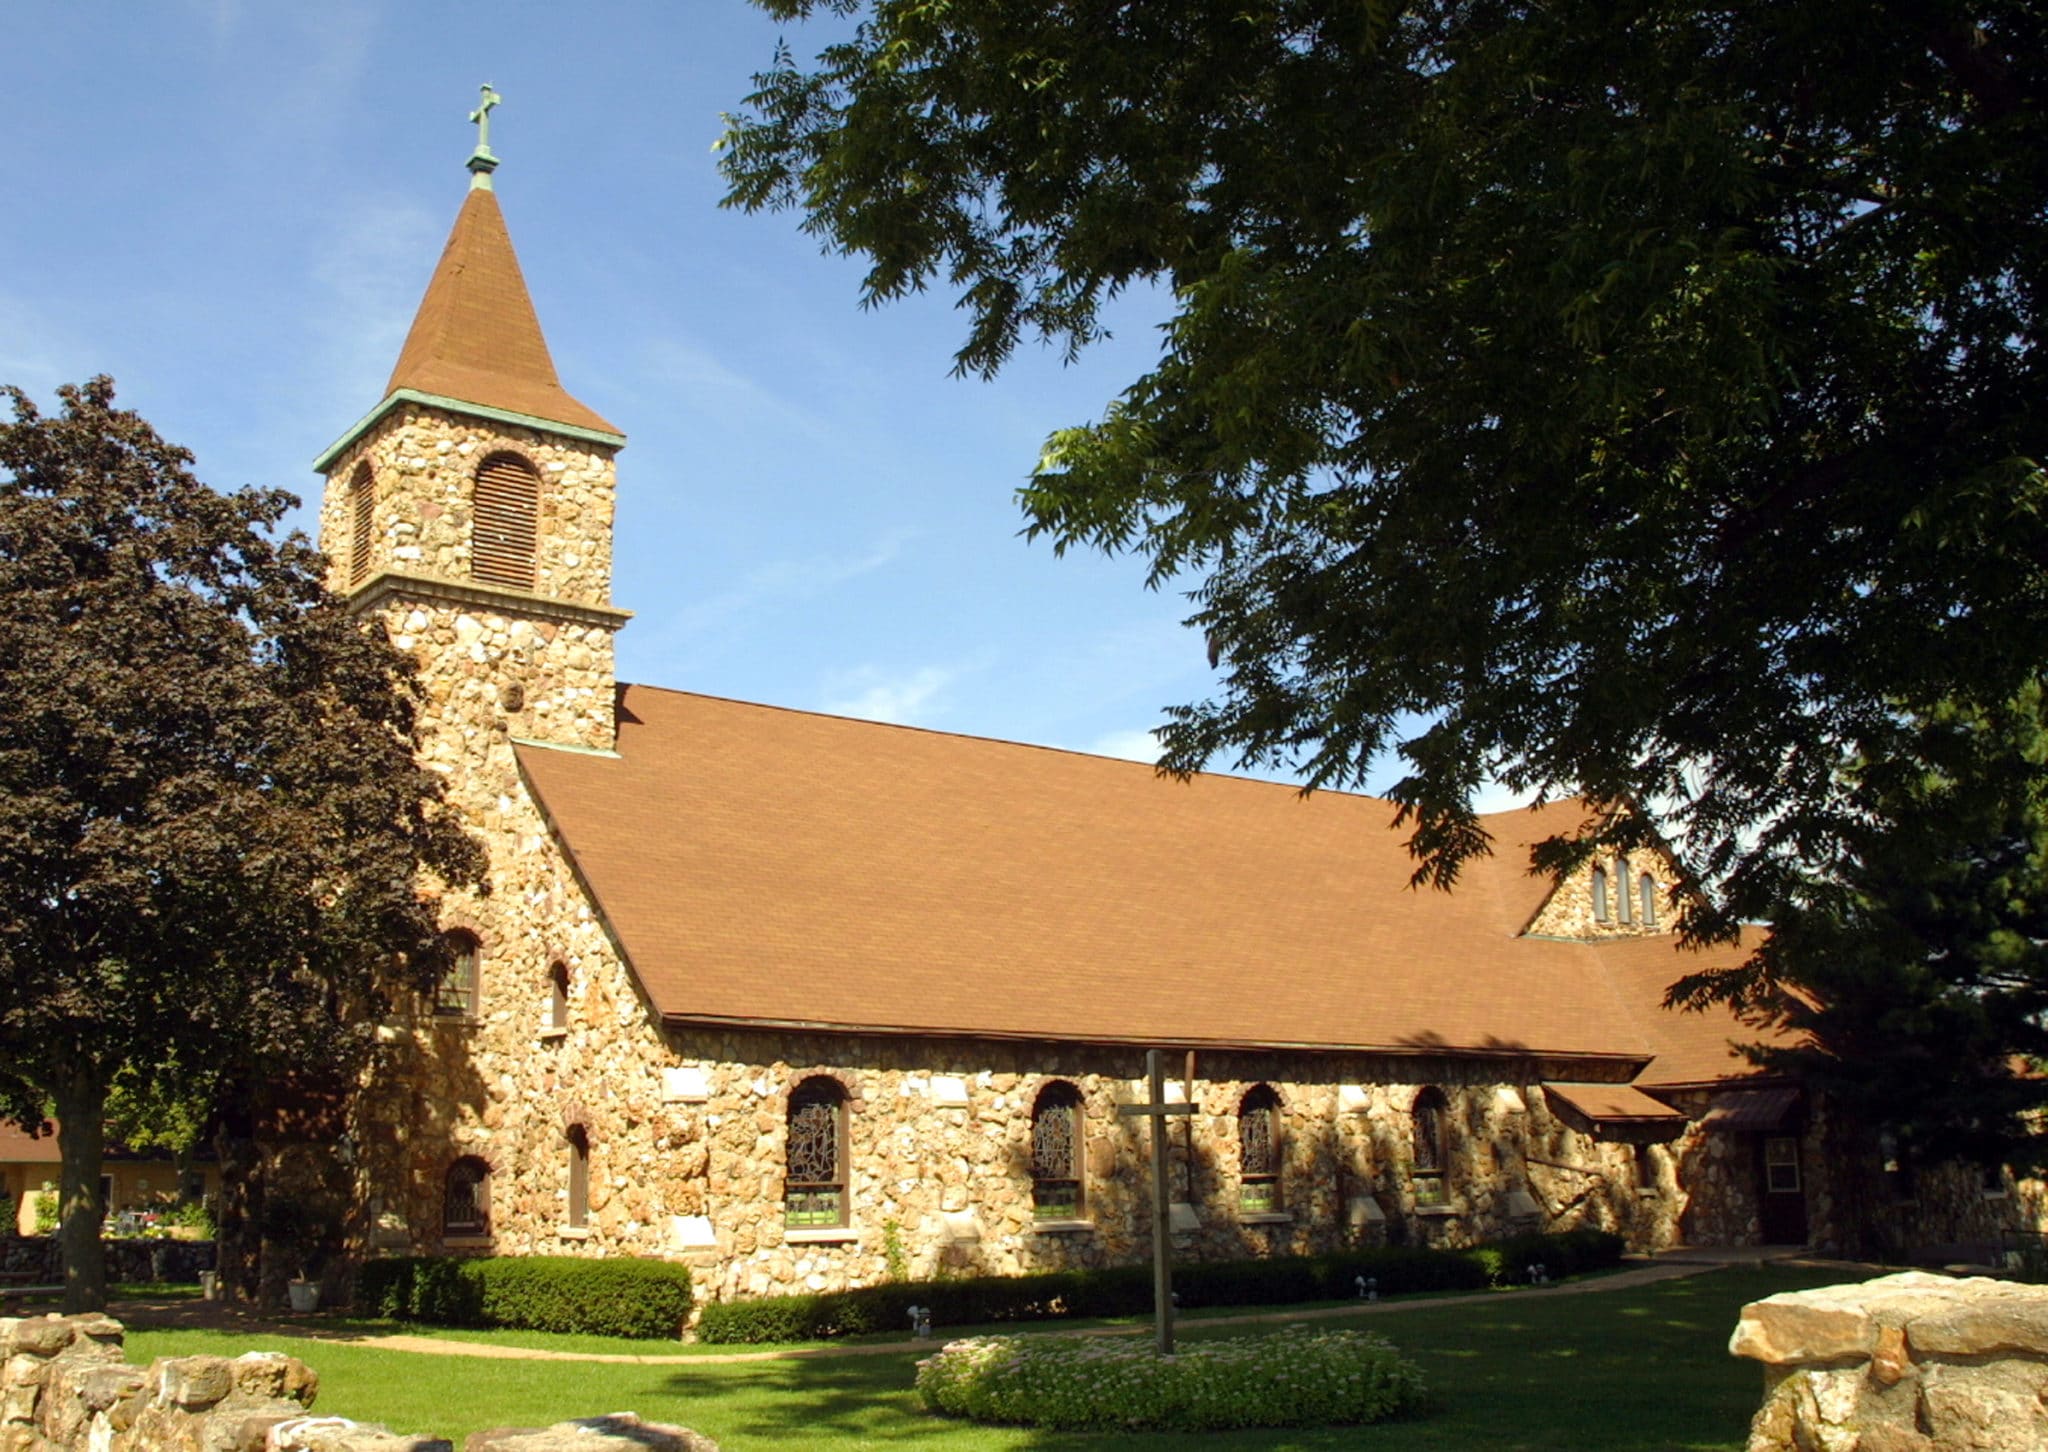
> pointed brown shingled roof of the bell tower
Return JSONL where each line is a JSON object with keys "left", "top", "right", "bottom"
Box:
{"left": 385, "top": 188, "right": 618, "bottom": 434}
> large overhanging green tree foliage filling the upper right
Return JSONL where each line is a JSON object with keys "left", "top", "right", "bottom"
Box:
{"left": 723, "top": 0, "right": 2048, "bottom": 938}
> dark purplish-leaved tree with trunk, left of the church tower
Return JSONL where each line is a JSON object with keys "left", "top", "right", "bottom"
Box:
{"left": 0, "top": 379, "right": 481, "bottom": 1311}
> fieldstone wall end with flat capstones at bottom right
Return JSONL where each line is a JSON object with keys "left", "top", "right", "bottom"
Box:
{"left": 1729, "top": 1272, "right": 2048, "bottom": 1452}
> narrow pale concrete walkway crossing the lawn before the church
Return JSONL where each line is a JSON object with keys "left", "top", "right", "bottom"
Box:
{"left": 109, "top": 1245, "right": 1868, "bottom": 1366}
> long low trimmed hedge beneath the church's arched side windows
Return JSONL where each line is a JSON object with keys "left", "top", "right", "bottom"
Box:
{"left": 696, "top": 1231, "right": 1622, "bottom": 1343}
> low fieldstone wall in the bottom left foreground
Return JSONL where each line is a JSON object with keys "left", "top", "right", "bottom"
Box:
{"left": 0, "top": 1315, "right": 719, "bottom": 1452}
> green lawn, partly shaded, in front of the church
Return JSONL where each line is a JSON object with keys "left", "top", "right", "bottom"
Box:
{"left": 129, "top": 1268, "right": 1843, "bottom": 1452}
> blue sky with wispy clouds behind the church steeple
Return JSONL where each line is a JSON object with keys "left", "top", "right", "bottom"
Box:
{"left": 0, "top": 0, "right": 1523, "bottom": 802}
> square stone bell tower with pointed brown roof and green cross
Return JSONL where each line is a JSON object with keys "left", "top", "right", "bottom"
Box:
{"left": 313, "top": 86, "right": 629, "bottom": 770}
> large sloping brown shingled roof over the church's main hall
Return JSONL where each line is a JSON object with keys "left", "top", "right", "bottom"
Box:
{"left": 518, "top": 686, "right": 1777, "bottom": 1077}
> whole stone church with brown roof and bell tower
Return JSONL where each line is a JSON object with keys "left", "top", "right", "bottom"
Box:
{"left": 315, "top": 130, "right": 2038, "bottom": 1298}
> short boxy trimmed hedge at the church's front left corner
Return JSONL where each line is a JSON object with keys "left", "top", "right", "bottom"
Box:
{"left": 356, "top": 1255, "right": 690, "bottom": 1341}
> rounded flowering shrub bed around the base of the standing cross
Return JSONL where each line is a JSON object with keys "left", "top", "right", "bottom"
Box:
{"left": 918, "top": 1327, "right": 1423, "bottom": 1432}
